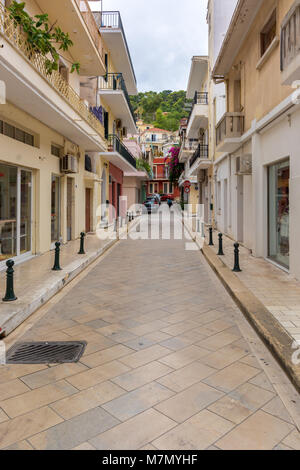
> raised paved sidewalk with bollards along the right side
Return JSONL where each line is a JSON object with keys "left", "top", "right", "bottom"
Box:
{"left": 185, "top": 219, "right": 300, "bottom": 391}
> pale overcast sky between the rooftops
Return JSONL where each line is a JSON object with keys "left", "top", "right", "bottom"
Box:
{"left": 99, "top": 0, "right": 207, "bottom": 91}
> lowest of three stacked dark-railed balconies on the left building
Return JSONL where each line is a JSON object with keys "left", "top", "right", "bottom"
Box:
{"left": 101, "top": 134, "right": 137, "bottom": 173}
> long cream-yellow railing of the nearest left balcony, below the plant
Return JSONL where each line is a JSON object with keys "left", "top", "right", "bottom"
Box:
{"left": 0, "top": 3, "right": 104, "bottom": 138}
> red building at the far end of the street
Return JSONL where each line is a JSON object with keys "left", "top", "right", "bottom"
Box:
{"left": 147, "top": 157, "right": 180, "bottom": 199}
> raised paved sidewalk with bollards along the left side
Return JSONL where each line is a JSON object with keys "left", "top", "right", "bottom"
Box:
{"left": 0, "top": 222, "right": 135, "bottom": 336}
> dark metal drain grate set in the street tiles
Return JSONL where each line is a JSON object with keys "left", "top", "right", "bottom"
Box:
{"left": 6, "top": 341, "right": 87, "bottom": 364}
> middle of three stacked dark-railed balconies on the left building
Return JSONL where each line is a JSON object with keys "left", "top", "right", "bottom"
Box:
{"left": 99, "top": 73, "right": 137, "bottom": 134}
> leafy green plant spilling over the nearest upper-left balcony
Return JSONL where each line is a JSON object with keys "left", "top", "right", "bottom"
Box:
{"left": 8, "top": 1, "right": 80, "bottom": 74}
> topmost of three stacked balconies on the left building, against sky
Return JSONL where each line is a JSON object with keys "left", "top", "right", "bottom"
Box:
{"left": 94, "top": 11, "right": 137, "bottom": 95}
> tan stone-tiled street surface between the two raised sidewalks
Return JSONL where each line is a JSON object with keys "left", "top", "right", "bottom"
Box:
{"left": 0, "top": 211, "right": 300, "bottom": 450}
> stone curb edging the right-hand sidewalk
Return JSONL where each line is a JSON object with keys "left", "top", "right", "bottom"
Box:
{"left": 183, "top": 218, "right": 300, "bottom": 393}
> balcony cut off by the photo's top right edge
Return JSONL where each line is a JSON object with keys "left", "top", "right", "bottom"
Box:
{"left": 280, "top": 1, "right": 300, "bottom": 85}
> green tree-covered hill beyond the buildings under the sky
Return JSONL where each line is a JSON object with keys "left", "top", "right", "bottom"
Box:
{"left": 130, "top": 90, "right": 189, "bottom": 131}
